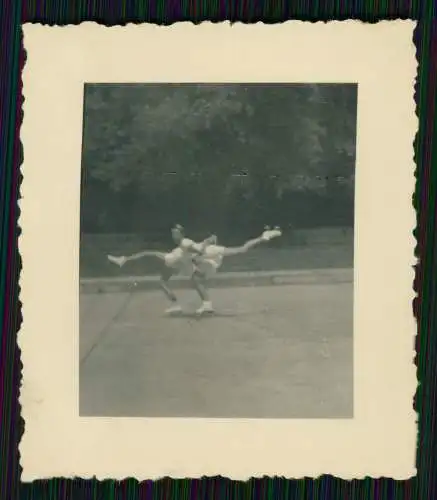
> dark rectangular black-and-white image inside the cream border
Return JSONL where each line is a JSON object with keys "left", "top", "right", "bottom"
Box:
{"left": 79, "top": 83, "right": 358, "bottom": 419}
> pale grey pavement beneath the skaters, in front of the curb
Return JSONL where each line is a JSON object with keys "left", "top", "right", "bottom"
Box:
{"left": 80, "top": 283, "right": 353, "bottom": 418}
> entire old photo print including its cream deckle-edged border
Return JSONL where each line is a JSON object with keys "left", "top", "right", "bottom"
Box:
{"left": 18, "top": 21, "right": 417, "bottom": 481}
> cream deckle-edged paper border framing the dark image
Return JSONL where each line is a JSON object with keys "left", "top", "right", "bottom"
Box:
{"left": 19, "top": 21, "right": 417, "bottom": 481}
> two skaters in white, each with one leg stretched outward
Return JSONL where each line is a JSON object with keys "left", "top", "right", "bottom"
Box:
{"left": 108, "top": 224, "right": 282, "bottom": 314}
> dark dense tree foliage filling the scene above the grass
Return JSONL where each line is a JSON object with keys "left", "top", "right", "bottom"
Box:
{"left": 82, "top": 84, "right": 357, "bottom": 239}
